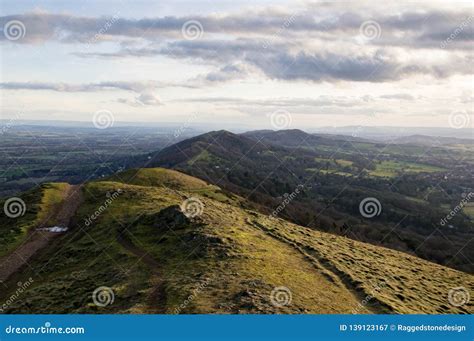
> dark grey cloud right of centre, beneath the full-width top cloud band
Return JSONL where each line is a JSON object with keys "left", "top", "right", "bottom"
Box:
{"left": 166, "top": 40, "right": 472, "bottom": 82}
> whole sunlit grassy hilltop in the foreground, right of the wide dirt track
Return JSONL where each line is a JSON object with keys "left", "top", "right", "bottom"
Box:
{"left": 0, "top": 169, "right": 474, "bottom": 313}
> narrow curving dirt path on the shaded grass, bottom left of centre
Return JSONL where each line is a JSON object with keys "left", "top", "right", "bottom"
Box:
{"left": 117, "top": 233, "right": 166, "bottom": 314}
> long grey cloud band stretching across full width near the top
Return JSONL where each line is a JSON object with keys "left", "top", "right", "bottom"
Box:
{"left": 0, "top": 8, "right": 474, "bottom": 48}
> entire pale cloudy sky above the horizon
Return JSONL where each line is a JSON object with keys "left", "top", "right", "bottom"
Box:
{"left": 0, "top": 0, "right": 474, "bottom": 129}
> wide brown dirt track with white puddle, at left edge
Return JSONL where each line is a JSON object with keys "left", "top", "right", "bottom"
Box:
{"left": 0, "top": 185, "right": 82, "bottom": 282}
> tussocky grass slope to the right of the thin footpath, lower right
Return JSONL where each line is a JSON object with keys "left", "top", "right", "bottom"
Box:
{"left": 246, "top": 217, "right": 474, "bottom": 313}
